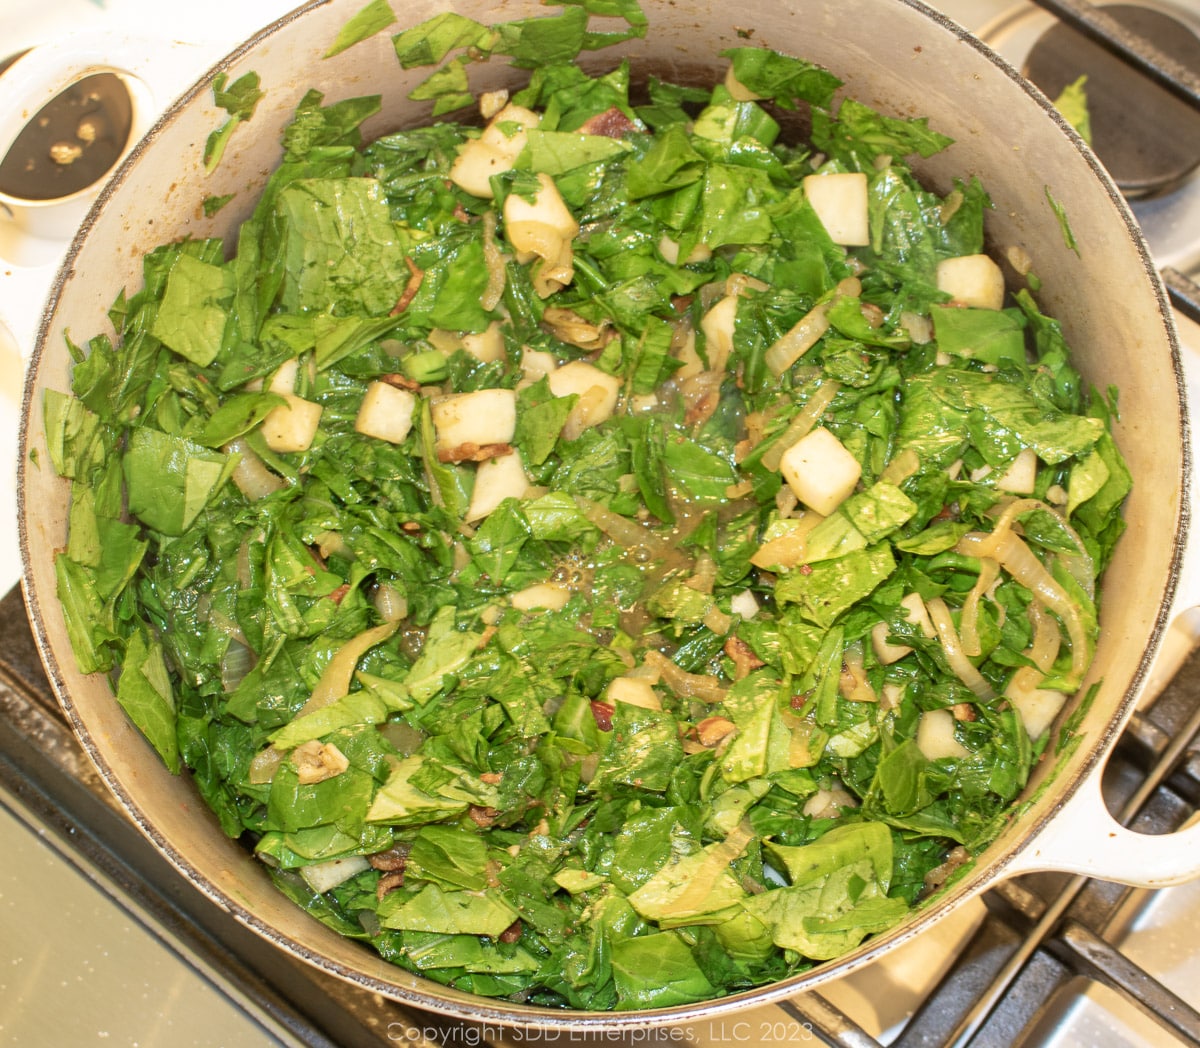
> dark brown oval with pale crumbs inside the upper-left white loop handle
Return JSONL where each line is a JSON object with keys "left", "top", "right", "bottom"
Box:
{"left": 0, "top": 73, "right": 133, "bottom": 200}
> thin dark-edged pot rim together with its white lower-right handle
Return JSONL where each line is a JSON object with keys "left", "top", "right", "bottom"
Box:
{"left": 9, "top": 0, "right": 1200, "bottom": 1030}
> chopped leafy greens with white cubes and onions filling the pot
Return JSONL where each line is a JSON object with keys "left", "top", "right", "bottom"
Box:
{"left": 43, "top": 0, "right": 1132, "bottom": 1011}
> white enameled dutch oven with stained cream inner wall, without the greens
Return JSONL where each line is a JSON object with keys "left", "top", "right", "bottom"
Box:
{"left": 9, "top": 0, "right": 1200, "bottom": 1030}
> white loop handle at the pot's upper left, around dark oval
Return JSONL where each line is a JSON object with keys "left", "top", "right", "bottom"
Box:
{"left": 0, "top": 31, "right": 227, "bottom": 358}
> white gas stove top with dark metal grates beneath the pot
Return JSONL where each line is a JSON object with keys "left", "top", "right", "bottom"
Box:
{"left": 0, "top": 0, "right": 1200, "bottom": 1048}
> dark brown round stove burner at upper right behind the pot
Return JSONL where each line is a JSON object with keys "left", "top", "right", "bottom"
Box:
{"left": 1022, "top": 4, "right": 1200, "bottom": 197}
